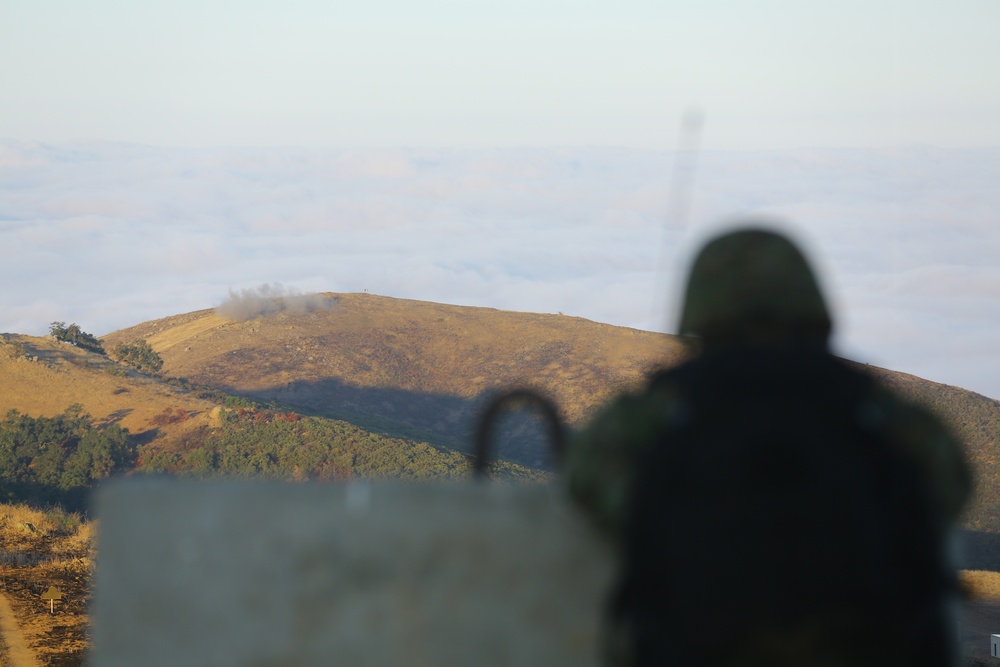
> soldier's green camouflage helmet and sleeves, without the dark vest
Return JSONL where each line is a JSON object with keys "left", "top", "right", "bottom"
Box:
{"left": 566, "top": 229, "right": 971, "bottom": 664}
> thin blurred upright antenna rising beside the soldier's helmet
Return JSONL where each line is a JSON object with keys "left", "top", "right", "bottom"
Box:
{"left": 650, "top": 108, "right": 705, "bottom": 334}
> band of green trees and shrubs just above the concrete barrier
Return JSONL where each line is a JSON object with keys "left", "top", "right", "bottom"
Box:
{"left": 0, "top": 404, "right": 545, "bottom": 511}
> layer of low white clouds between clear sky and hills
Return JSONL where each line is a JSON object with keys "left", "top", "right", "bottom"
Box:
{"left": 0, "top": 141, "right": 1000, "bottom": 398}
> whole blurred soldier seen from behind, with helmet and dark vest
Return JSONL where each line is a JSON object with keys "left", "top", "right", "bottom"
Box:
{"left": 567, "top": 229, "right": 970, "bottom": 666}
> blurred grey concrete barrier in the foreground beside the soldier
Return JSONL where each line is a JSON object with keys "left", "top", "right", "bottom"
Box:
{"left": 90, "top": 479, "right": 612, "bottom": 667}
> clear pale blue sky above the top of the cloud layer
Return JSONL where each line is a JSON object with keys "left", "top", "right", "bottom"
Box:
{"left": 0, "top": 0, "right": 1000, "bottom": 148}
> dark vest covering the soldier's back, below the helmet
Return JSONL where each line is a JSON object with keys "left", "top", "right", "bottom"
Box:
{"left": 613, "top": 345, "right": 957, "bottom": 666}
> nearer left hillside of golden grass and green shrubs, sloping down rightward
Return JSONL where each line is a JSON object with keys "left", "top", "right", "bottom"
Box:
{"left": 0, "top": 334, "right": 539, "bottom": 509}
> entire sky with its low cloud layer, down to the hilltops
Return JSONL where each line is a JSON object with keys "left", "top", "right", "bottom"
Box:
{"left": 0, "top": 0, "right": 1000, "bottom": 398}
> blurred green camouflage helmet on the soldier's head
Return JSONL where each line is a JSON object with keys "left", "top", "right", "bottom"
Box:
{"left": 680, "top": 228, "right": 832, "bottom": 348}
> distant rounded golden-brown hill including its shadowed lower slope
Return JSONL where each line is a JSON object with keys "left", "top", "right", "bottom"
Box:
{"left": 99, "top": 294, "right": 1000, "bottom": 533}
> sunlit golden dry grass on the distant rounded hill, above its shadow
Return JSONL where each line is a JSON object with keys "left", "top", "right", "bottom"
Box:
{"left": 104, "top": 293, "right": 696, "bottom": 423}
